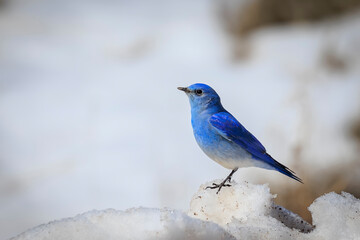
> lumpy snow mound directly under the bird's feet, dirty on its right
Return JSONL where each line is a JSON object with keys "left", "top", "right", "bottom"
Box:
{"left": 189, "top": 182, "right": 313, "bottom": 239}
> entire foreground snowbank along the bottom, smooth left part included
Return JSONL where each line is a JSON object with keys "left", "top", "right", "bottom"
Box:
{"left": 13, "top": 182, "right": 360, "bottom": 240}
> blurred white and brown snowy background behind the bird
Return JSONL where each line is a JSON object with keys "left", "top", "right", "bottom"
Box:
{"left": 0, "top": 0, "right": 360, "bottom": 239}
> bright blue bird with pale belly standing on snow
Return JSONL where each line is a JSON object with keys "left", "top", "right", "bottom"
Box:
{"left": 178, "top": 83, "right": 302, "bottom": 193}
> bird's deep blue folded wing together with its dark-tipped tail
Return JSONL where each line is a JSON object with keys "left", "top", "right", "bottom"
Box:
{"left": 209, "top": 112, "right": 302, "bottom": 182}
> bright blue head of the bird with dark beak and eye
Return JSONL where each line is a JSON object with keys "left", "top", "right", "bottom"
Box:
{"left": 178, "top": 83, "right": 222, "bottom": 112}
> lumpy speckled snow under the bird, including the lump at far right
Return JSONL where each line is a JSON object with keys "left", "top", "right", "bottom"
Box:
{"left": 189, "top": 180, "right": 360, "bottom": 239}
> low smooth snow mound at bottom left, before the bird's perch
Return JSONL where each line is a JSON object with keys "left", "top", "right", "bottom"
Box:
{"left": 14, "top": 208, "right": 235, "bottom": 240}
